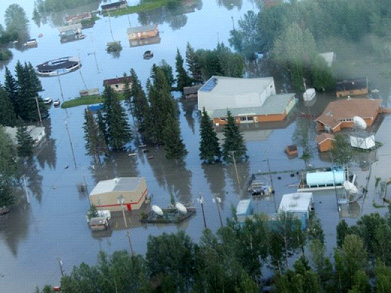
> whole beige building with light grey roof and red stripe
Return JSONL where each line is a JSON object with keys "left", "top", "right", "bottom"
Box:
{"left": 89, "top": 177, "right": 148, "bottom": 212}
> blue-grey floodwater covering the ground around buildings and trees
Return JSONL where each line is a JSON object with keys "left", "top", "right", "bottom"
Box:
{"left": 0, "top": 0, "right": 391, "bottom": 292}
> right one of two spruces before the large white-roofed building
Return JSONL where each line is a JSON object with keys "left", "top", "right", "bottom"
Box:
{"left": 222, "top": 110, "right": 247, "bottom": 162}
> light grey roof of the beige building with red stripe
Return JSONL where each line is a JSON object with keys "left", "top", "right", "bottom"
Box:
{"left": 90, "top": 177, "right": 144, "bottom": 195}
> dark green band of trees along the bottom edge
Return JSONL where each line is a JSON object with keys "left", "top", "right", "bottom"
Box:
{"left": 36, "top": 206, "right": 391, "bottom": 293}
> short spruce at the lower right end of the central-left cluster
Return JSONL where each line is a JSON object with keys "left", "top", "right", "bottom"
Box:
{"left": 163, "top": 116, "right": 188, "bottom": 160}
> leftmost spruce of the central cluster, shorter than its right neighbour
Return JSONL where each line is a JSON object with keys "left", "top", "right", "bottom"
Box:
{"left": 83, "top": 109, "right": 107, "bottom": 162}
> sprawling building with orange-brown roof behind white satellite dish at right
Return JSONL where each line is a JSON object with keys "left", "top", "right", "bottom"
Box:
{"left": 316, "top": 99, "right": 382, "bottom": 133}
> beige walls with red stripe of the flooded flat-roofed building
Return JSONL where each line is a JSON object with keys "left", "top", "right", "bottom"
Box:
{"left": 90, "top": 179, "right": 147, "bottom": 212}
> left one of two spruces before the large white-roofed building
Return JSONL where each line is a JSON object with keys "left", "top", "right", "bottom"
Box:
{"left": 199, "top": 108, "right": 221, "bottom": 164}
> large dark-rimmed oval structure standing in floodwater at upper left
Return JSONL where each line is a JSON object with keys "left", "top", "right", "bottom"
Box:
{"left": 35, "top": 57, "right": 81, "bottom": 76}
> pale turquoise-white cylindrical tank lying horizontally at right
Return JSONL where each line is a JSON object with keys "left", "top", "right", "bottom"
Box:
{"left": 306, "top": 168, "right": 346, "bottom": 187}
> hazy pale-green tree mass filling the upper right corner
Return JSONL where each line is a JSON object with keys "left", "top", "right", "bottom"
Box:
{"left": 229, "top": 0, "right": 391, "bottom": 91}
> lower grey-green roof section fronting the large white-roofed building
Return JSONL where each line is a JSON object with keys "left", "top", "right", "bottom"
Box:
{"left": 210, "top": 93, "right": 295, "bottom": 118}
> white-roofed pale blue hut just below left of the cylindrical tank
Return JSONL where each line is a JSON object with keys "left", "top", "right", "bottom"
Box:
{"left": 278, "top": 192, "right": 313, "bottom": 229}
